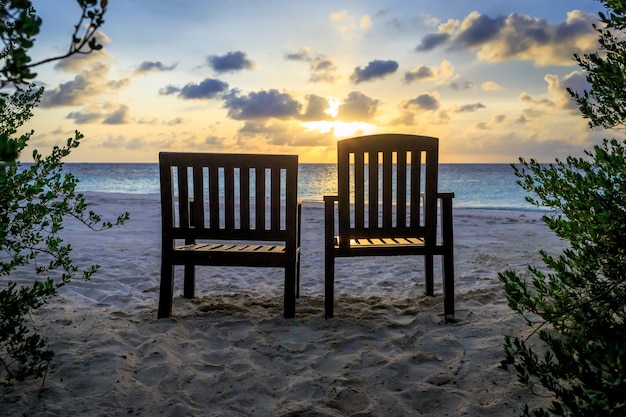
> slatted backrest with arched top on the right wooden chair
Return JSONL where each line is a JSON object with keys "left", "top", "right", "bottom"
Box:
{"left": 337, "top": 134, "right": 439, "bottom": 245}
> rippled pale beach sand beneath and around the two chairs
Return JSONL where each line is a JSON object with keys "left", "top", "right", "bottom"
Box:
{"left": 0, "top": 194, "right": 562, "bottom": 417}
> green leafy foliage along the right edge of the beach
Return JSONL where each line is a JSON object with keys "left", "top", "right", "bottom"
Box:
{"left": 498, "top": 0, "right": 626, "bottom": 417}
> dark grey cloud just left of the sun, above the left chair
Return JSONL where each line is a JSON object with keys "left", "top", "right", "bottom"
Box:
{"left": 224, "top": 89, "right": 302, "bottom": 120}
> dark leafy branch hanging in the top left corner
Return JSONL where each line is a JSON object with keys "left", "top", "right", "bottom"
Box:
{"left": 0, "top": 0, "right": 108, "bottom": 92}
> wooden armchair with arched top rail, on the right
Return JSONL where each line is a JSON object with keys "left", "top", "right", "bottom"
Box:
{"left": 324, "top": 134, "right": 454, "bottom": 321}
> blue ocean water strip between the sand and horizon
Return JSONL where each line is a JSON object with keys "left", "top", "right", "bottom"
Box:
{"left": 56, "top": 163, "right": 537, "bottom": 210}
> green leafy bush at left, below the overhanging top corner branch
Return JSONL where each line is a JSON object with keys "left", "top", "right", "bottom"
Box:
{"left": 0, "top": 88, "right": 128, "bottom": 381}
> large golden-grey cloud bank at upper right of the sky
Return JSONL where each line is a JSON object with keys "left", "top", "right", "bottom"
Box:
{"left": 416, "top": 10, "right": 598, "bottom": 66}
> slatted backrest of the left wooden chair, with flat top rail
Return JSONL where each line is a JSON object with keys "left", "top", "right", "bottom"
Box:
{"left": 159, "top": 152, "right": 298, "bottom": 246}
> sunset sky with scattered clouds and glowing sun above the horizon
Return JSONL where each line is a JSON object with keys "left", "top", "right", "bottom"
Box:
{"left": 27, "top": 0, "right": 607, "bottom": 163}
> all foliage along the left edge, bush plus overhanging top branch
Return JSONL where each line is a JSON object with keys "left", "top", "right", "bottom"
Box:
{"left": 0, "top": 0, "right": 129, "bottom": 383}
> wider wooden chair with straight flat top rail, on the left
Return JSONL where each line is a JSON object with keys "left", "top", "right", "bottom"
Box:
{"left": 158, "top": 152, "right": 301, "bottom": 318}
